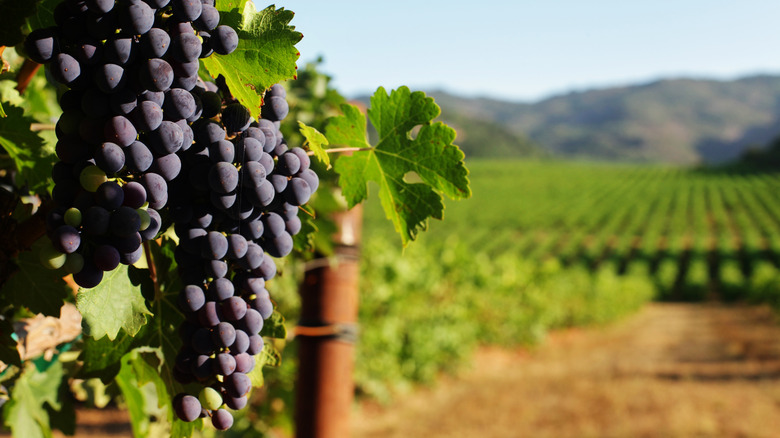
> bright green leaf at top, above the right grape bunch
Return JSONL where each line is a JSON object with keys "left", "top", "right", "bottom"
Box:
{"left": 203, "top": 0, "right": 303, "bottom": 119}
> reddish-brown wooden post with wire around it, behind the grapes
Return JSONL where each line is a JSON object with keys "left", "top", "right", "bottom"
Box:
{"left": 295, "top": 205, "right": 363, "bottom": 438}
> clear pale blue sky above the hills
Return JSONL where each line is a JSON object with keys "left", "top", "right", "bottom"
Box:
{"left": 272, "top": 0, "right": 780, "bottom": 101}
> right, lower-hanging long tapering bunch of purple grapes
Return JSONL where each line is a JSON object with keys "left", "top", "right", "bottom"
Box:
{"left": 170, "top": 85, "right": 319, "bottom": 428}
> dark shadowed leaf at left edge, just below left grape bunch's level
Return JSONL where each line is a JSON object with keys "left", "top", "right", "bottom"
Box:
{"left": 0, "top": 237, "right": 72, "bottom": 317}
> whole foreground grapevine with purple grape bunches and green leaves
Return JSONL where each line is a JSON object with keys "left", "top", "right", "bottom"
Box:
{"left": 0, "top": 0, "right": 468, "bottom": 436}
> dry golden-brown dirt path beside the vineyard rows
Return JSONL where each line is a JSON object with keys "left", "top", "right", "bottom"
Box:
{"left": 353, "top": 304, "right": 780, "bottom": 438}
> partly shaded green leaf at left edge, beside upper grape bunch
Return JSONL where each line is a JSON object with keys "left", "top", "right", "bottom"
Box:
{"left": 0, "top": 105, "right": 57, "bottom": 192}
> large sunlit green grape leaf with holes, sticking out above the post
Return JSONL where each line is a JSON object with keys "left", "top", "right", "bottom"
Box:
{"left": 325, "top": 87, "right": 471, "bottom": 246}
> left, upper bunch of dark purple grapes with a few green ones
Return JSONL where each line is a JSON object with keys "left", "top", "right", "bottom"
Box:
{"left": 24, "top": 0, "right": 238, "bottom": 288}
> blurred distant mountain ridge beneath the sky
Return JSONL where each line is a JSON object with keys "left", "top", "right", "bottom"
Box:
{"left": 428, "top": 75, "right": 780, "bottom": 164}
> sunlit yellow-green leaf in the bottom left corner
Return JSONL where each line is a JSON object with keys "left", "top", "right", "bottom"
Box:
{"left": 3, "top": 361, "right": 64, "bottom": 438}
